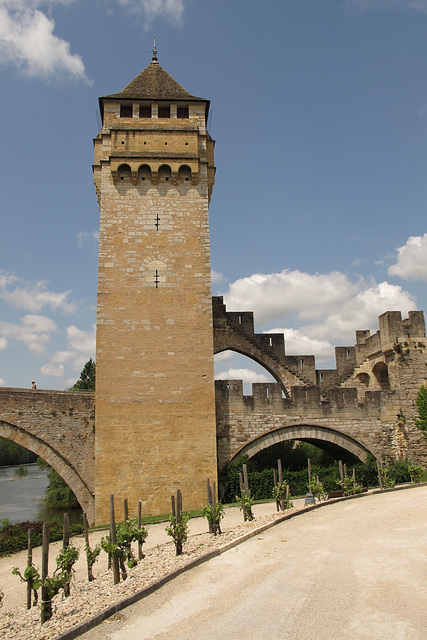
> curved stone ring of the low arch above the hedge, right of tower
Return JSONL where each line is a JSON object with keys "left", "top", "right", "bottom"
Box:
{"left": 231, "top": 424, "right": 372, "bottom": 463}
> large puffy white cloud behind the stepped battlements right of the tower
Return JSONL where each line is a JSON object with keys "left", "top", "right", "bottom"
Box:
{"left": 224, "top": 269, "right": 416, "bottom": 350}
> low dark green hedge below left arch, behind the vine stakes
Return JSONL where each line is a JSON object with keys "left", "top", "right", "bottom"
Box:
{"left": 0, "top": 522, "right": 83, "bottom": 556}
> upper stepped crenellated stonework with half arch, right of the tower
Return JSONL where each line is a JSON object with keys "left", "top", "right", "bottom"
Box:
{"left": 212, "top": 297, "right": 427, "bottom": 400}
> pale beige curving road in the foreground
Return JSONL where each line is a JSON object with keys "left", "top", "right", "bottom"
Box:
{"left": 83, "top": 487, "right": 427, "bottom": 640}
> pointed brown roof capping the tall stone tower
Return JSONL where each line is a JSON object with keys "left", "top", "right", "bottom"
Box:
{"left": 105, "top": 62, "right": 207, "bottom": 102}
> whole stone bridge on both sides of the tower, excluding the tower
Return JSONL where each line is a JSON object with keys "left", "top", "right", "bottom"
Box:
{"left": 0, "top": 298, "right": 427, "bottom": 523}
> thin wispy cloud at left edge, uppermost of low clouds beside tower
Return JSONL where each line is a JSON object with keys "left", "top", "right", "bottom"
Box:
{"left": 0, "top": 271, "right": 76, "bottom": 313}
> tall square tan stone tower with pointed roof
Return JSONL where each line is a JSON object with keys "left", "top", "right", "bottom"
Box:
{"left": 94, "top": 52, "right": 217, "bottom": 523}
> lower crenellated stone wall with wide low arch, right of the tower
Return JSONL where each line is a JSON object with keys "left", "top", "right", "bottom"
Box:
{"left": 215, "top": 380, "right": 404, "bottom": 470}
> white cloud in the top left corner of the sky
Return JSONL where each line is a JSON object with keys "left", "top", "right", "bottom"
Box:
{"left": 0, "top": 0, "right": 89, "bottom": 82}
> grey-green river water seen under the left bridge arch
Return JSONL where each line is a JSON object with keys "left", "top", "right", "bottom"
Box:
{"left": 0, "top": 464, "right": 81, "bottom": 524}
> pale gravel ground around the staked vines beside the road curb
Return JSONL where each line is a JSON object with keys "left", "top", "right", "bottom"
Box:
{"left": 0, "top": 501, "right": 303, "bottom": 640}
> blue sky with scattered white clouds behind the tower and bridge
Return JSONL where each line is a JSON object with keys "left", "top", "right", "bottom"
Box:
{"left": 0, "top": 0, "right": 427, "bottom": 389}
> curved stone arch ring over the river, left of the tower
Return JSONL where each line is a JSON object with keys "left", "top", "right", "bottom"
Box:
{"left": 0, "top": 420, "right": 95, "bottom": 524}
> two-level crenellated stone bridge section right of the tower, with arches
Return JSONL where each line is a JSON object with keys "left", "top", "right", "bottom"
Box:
{"left": 213, "top": 297, "right": 427, "bottom": 470}
